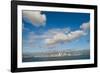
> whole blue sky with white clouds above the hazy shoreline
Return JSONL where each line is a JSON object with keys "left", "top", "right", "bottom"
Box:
{"left": 22, "top": 10, "right": 90, "bottom": 53}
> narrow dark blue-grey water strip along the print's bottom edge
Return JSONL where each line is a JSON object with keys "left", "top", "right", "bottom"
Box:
{"left": 23, "top": 54, "right": 90, "bottom": 62}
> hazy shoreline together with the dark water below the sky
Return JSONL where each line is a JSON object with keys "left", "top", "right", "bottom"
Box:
{"left": 22, "top": 50, "right": 90, "bottom": 62}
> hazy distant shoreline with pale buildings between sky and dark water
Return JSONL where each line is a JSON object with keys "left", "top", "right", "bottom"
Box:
{"left": 23, "top": 50, "right": 90, "bottom": 58}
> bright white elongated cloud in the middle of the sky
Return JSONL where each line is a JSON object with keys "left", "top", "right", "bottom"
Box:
{"left": 45, "top": 30, "right": 85, "bottom": 45}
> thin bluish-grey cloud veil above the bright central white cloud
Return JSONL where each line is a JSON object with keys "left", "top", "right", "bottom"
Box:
{"left": 26, "top": 28, "right": 69, "bottom": 41}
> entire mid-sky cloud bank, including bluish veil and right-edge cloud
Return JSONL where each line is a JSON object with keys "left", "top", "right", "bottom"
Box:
{"left": 22, "top": 22, "right": 90, "bottom": 48}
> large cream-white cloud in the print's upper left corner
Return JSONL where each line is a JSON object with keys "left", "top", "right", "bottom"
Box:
{"left": 23, "top": 10, "right": 46, "bottom": 27}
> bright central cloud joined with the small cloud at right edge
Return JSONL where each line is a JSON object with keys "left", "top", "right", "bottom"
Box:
{"left": 45, "top": 22, "right": 90, "bottom": 46}
